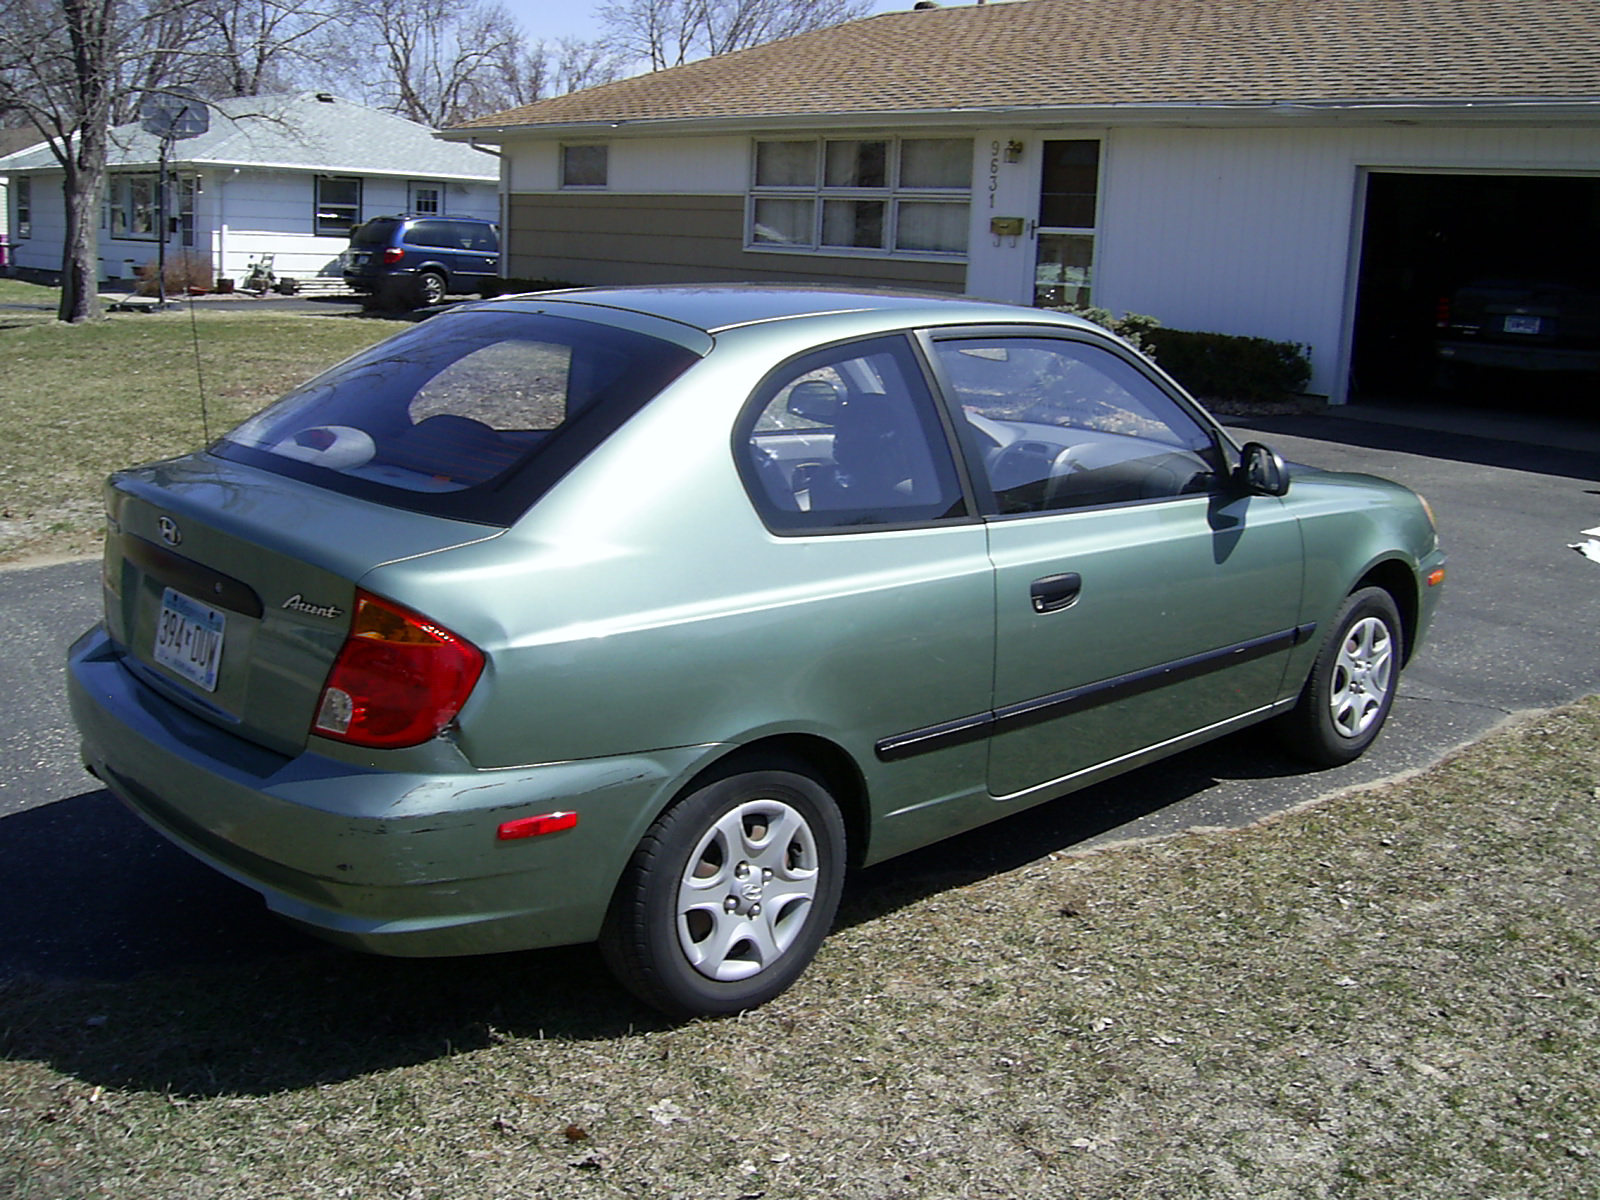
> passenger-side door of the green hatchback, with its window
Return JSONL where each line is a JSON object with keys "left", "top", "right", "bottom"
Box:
{"left": 930, "top": 331, "right": 1302, "bottom": 798}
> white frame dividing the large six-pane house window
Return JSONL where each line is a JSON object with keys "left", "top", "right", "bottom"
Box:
{"left": 744, "top": 133, "right": 973, "bottom": 262}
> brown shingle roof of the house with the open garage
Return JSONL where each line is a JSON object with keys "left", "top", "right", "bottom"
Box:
{"left": 454, "top": 0, "right": 1600, "bottom": 131}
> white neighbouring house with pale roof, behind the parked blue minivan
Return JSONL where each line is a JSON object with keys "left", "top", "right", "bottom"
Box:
{"left": 0, "top": 91, "right": 499, "bottom": 292}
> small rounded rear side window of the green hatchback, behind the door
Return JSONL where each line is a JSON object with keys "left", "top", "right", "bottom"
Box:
{"left": 734, "top": 338, "right": 966, "bottom": 533}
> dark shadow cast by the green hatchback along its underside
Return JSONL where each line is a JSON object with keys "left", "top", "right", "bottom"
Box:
{"left": 0, "top": 734, "right": 1318, "bottom": 1098}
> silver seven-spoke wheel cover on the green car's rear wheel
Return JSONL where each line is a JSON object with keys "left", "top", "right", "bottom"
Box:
{"left": 677, "top": 800, "right": 819, "bottom": 982}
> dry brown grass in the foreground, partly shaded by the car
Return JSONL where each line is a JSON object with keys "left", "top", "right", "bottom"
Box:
{"left": 0, "top": 701, "right": 1600, "bottom": 1200}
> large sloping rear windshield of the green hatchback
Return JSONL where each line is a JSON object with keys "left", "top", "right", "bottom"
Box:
{"left": 213, "top": 309, "right": 696, "bottom": 523}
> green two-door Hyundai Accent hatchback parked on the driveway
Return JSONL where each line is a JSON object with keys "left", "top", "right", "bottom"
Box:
{"left": 69, "top": 286, "right": 1443, "bottom": 1014}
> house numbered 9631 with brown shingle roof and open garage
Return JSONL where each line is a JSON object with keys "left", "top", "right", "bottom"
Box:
{"left": 440, "top": 0, "right": 1600, "bottom": 400}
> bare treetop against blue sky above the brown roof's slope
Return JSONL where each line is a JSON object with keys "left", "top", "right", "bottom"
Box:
{"left": 598, "top": 0, "right": 869, "bottom": 70}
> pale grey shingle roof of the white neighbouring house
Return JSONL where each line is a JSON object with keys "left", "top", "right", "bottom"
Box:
{"left": 5, "top": 91, "right": 499, "bottom": 181}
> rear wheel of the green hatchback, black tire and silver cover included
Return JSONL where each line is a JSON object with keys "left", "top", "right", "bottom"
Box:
{"left": 600, "top": 763, "right": 845, "bottom": 1018}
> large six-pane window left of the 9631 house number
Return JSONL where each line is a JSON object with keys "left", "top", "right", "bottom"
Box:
{"left": 746, "top": 138, "right": 973, "bottom": 256}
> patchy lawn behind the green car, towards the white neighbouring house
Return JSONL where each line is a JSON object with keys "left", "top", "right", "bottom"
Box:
{"left": 0, "top": 300, "right": 400, "bottom": 562}
